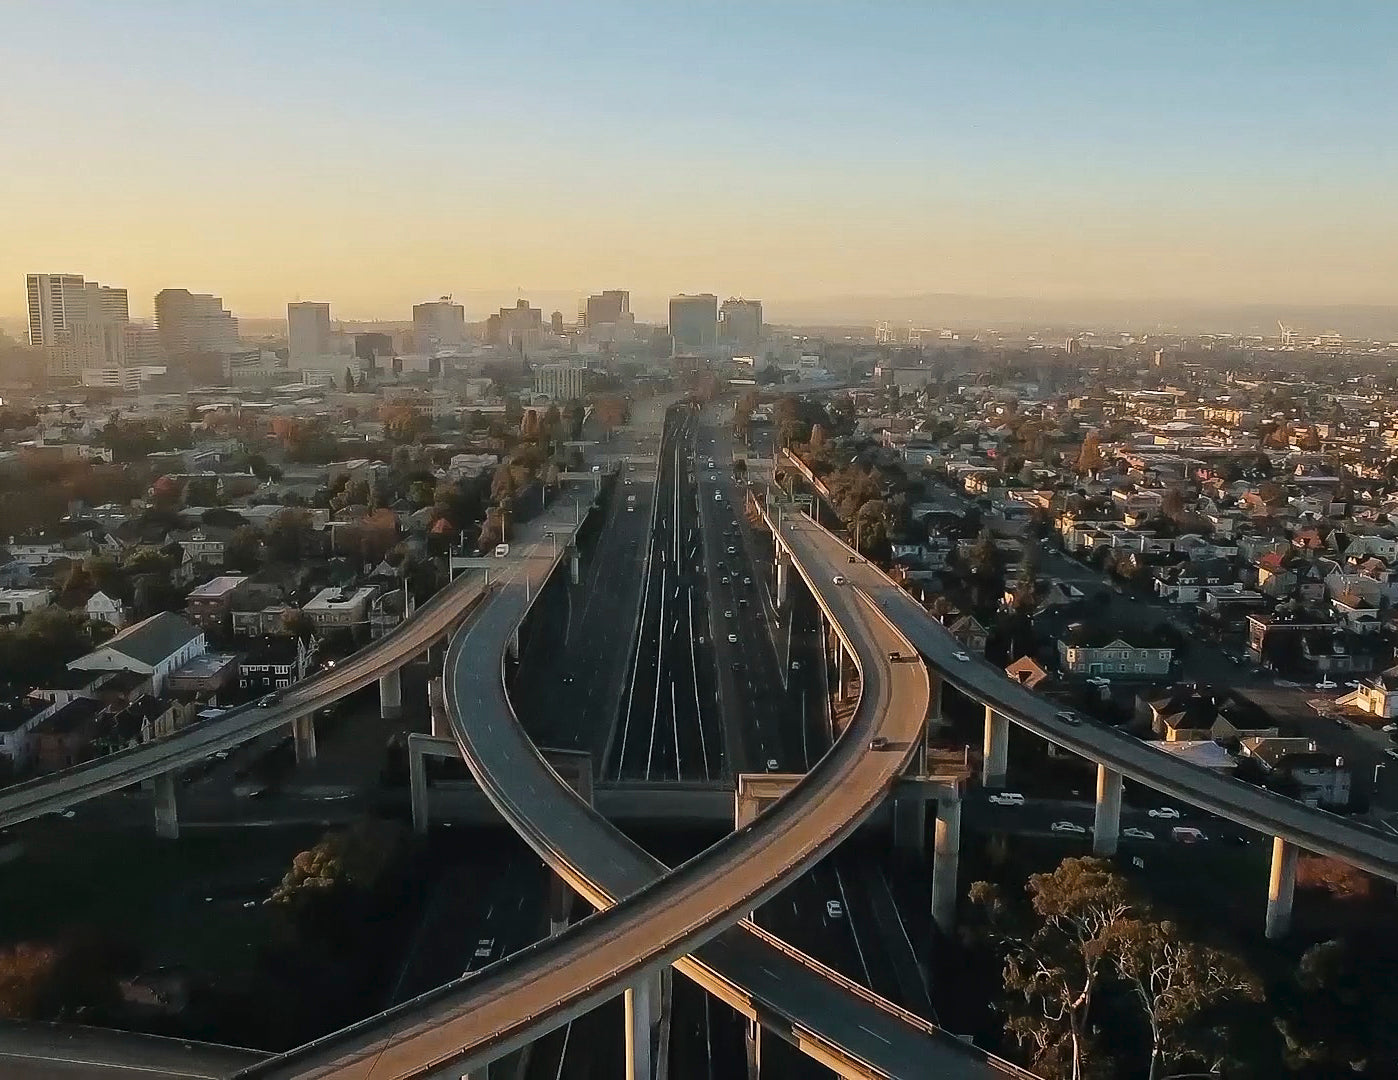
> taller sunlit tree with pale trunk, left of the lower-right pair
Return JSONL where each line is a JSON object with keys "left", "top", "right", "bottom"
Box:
{"left": 970, "top": 858, "right": 1132, "bottom": 1080}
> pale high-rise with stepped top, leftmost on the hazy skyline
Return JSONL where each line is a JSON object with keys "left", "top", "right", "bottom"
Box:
{"left": 24, "top": 274, "right": 130, "bottom": 380}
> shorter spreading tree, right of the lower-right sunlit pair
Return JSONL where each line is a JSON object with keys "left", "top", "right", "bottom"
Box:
{"left": 1107, "top": 918, "right": 1261, "bottom": 1080}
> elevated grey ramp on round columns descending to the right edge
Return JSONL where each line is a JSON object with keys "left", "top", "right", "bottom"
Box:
{"left": 783, "top": 483, "right": 1398, "bottom": 880}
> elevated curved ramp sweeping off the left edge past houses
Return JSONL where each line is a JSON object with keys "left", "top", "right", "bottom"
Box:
{"left": 0, "top": 564, "right": 497, "bottom": 829}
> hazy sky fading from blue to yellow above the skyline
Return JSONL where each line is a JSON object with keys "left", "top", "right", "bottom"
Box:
{"left": 0, "top": 0, "right": 1398, "bottom": 319}
